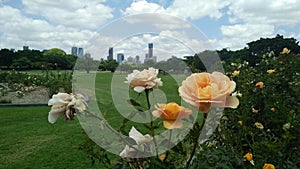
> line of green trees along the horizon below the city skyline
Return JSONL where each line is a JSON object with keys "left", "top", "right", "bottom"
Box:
{"left": 0, "top": 35, "right": 300, "bottom": 73}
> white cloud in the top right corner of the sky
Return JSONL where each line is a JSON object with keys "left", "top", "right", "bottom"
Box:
{"left": 228, "top": 0, "right": 300, "bottom": 26}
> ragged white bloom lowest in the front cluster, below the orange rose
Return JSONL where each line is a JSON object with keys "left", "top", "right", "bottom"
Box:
{"left": 120, "top": 126, "right": 153, "bottom": 157}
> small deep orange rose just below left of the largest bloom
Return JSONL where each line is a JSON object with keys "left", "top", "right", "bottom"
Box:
{"left": 152, "top": 102, "right": 192, "bottom": 129}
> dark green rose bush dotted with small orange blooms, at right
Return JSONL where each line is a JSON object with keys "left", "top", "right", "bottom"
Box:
{"left": 193, "top": 49, "right": 300, "bottom": 168}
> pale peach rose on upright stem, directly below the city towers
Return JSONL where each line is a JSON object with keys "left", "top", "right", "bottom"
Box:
{"left": 125, "top": 67, "right": 162, "bottom": 93}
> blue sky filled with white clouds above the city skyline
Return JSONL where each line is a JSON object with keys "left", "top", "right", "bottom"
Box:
{"left": 0, "top": 0, "right": 300, "bottom": 60}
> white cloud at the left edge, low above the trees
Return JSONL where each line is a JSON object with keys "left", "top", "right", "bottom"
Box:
{"left": 0, "top": 6, "right": 93, "bottom": 53}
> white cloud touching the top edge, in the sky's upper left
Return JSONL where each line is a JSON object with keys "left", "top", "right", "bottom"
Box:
{"left": 23, "top": 0, "right": 113, "bottom": 29}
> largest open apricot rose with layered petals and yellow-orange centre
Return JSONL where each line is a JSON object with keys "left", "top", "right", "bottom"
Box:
{"left": 178, "top": 72, "right": 239, "bottom": 113}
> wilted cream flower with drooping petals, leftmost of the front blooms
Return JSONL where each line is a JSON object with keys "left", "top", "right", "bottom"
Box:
{"left": 48, "top": 93, "right": 87, "bottom": 124}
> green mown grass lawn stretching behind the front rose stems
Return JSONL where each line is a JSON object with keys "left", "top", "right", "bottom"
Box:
{"left": 0, "top": 72, "right": 196, "bottom": 168}
